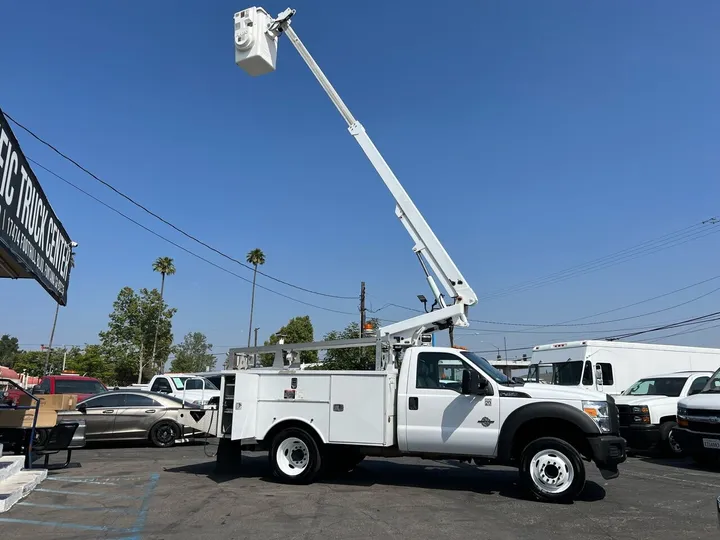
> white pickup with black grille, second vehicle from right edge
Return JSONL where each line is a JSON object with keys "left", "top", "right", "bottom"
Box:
{"left": 615, "top": 371, "right": 712, "bottom": 456}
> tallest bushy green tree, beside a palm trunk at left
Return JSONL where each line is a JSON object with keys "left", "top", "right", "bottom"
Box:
{"left": 100, "top": 287, "right": 177, "bottom": 385}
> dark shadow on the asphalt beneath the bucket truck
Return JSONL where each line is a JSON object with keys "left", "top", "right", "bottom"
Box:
{"left": 165, "top": 455, "right": 606, "bottom": 502}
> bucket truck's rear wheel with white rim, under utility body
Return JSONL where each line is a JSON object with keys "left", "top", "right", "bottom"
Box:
{"left": 270, "top": 428, "right": 322, "bottom": 484}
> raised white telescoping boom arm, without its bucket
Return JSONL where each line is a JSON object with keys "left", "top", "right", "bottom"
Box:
{"left": 235, "top": 8, "right": 477, "bottom": 339}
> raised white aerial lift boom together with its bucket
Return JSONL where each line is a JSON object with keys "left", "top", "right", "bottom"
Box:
{"left": 235, "top": 7, "right": 477, "bottom": 356}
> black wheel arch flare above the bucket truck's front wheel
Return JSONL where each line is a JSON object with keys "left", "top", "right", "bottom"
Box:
{"left": 497, "top": 402, "right": 600, "bottom": 457}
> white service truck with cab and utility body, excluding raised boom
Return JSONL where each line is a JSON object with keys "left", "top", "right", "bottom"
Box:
{"left": 180, "top": 346, "right": 626, "bottom": 501}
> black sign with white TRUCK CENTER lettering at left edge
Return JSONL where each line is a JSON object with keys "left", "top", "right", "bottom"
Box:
{"left": 0, "top": 110, "right": 72, "bottom": 306}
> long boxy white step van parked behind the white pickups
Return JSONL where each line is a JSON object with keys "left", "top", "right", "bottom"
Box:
{"left": 526, "top": 340, "right": 720, "bottom": 395}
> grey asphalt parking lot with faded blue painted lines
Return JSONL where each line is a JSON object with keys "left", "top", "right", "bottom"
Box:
{"left": 0, "top": 444, "right": 720, "bottom": 540}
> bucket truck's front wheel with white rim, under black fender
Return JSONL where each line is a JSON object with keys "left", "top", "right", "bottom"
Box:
{"left": 520, "top": 437, "right": 585, "bottom": 502}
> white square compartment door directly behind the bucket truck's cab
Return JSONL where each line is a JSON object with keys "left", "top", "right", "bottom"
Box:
{"left": 329, "top": 373, "right": 388, "bottom": 445}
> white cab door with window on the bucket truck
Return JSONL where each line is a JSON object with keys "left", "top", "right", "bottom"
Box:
{"left": 398, "top": 351, "right": 500, "bottom": 456}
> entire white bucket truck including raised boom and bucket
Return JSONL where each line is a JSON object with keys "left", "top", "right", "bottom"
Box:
{"left": 181, "top": 7, "right": 626, "bottom": 501}
